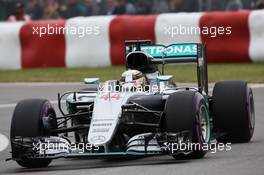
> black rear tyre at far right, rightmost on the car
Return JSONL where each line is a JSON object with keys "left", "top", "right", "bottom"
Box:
{"left": 213, "top": 81, "right": 255, "bottom": 143}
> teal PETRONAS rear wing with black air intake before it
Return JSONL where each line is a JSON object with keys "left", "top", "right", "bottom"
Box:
{"left": 125, "top": 40, "right": 208, "bottom": 93}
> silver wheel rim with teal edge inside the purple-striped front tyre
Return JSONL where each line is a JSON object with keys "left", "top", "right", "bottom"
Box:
{"left": 199, "top": 105, "right": 210, "bottom": 143}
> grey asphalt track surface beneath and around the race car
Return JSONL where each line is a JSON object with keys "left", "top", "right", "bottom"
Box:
{"left": 0, "top": 83, "right": 264, "bottom": 175}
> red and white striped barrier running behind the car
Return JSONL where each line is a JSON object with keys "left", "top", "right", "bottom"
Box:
{"left": 0, "top": 10, "right": 264, "bottom": 69}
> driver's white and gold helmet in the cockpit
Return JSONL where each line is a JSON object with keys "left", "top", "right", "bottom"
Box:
{"left": 120, "top": 70, "right": 146, "bottom": 88}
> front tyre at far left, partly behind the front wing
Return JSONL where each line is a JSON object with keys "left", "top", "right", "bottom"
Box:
{"left": 10, "top": 99, "right": 57, "bottom": 168}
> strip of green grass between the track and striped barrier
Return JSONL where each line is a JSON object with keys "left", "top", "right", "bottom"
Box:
{"left": 0, "top": 64, "right": 264, "bottom": 83}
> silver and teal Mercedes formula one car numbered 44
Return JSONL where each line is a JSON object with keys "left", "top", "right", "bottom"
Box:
{"left": 10, "top": 41, "right": 255, "bottom": 168}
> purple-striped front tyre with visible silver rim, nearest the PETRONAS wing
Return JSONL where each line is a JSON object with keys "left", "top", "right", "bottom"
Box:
{"left": 164, "top": 91, "right": 211, "bottom": 159}
